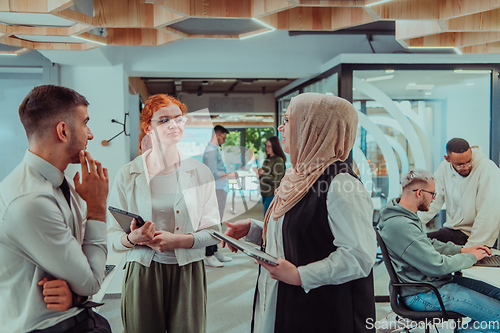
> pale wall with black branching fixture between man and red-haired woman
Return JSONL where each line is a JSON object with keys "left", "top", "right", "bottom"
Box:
{"left": 60, "top": 65, "right": 130, "bottom": 185}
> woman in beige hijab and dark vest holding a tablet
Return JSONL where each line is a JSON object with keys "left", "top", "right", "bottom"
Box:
{"left": 226, "top": 93, "right": 376, "bottom": 333}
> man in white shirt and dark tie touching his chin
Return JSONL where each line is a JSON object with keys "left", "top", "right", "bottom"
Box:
{"left": 0, "top": 85, "right": 111, "bottom": 333}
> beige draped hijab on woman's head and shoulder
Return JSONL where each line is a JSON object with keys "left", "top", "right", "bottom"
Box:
{"left": 262, "top": 93, "right": 358, "bottom": 243}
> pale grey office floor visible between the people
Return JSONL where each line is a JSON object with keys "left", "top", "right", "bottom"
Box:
{"left": 99, "top": 193, "right": 453, "bottom": 333}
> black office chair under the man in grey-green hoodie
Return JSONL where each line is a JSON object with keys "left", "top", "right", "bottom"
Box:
{"left": 375, "top": 229, "right": 465, "bottom": 333}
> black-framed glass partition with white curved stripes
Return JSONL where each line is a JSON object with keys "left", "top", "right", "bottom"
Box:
{"left": 277, "top": 64, "right": 500, "bottom": 209}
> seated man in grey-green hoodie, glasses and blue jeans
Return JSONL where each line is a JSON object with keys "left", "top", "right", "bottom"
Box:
{"left": 378, "top": 169, "right": 500, "bottom": 332}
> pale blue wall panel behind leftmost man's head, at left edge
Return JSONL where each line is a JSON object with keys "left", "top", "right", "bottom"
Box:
{"left": 0, "top": 70, "right": 43, "bottom": 181}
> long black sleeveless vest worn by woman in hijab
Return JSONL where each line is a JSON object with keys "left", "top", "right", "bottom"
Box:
{"left": 255, "top": 161, "right": 375, "bottom": 333}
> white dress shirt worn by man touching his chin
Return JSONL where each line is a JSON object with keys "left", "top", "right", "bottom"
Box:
{"left": 0, "top": 151, "right": 107, "bottom": 333}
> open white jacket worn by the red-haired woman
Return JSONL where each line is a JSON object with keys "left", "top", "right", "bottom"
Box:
{"left": 107, "top": 150, "right": 221, "bottom": 267}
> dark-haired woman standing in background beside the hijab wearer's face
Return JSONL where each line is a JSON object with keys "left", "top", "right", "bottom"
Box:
{"left": 257, "top": 136, "right": 286, "bottom": 216}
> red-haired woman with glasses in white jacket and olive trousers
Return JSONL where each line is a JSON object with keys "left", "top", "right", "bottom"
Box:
{"left": 108, "top": 94, "right": 220, "bottom": 333}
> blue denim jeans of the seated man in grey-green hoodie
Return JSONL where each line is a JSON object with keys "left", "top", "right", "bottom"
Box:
{"left": 403, "top": 276, "right": 500, "bottom": 333}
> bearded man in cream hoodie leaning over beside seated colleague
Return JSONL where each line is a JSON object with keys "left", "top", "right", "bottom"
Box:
{"left": 418, "top": 138, "right": 500, "bottom": 247}
